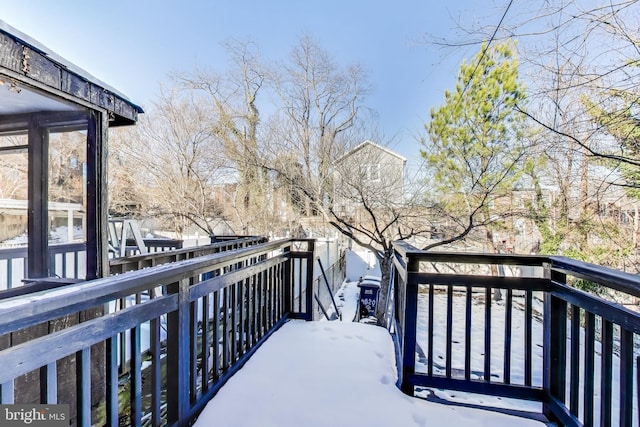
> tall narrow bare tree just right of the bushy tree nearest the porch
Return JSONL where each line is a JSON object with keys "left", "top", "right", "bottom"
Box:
{"left": 174, "top": 40, "right": 274, "bottom": 233}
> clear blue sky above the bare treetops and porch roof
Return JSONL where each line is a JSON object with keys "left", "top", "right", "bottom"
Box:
{"left": 0, "top": 0, "right": 506, "bottom": 162}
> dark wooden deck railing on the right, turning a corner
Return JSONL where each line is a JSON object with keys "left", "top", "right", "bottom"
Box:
{"left": 394, "top": 243, "right": 640, "bottom": 426}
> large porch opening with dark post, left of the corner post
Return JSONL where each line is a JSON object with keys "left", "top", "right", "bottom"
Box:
{"left": 0, "top": 76, "right": 88, "bottom": 290}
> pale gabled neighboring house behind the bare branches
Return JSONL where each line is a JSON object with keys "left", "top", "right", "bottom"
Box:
{"left": 333, "top": 140, "right": 407, "bottom": 213}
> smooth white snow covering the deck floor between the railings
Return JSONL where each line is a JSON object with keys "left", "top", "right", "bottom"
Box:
{"left": 195, "top": 321, "right": 544, "bottom": 427}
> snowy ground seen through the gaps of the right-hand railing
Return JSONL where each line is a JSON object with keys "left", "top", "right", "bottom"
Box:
{"left": 416, "top": 292, "right": 638, "bottom": 425}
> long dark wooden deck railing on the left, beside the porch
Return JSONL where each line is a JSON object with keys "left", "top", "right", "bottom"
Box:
{"left": 0, "top": 240, "right": 314, "bottom": 426}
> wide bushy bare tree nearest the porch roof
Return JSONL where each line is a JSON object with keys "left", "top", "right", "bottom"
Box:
{"left": 111, "top": 90, "right": 229, "bottom": 234}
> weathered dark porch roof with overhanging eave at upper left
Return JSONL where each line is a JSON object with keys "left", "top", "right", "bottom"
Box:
{"left": 0, "top": 21, "right": 143, "bottom": 126}
